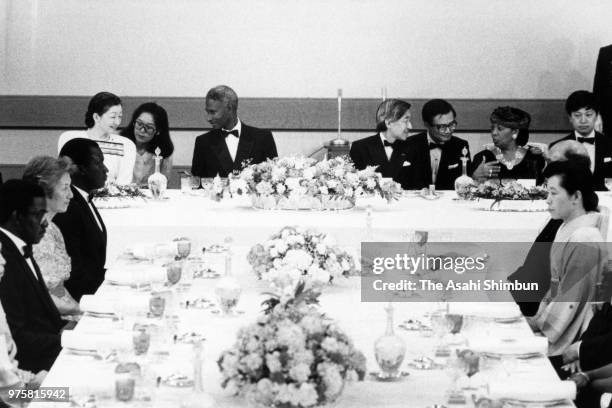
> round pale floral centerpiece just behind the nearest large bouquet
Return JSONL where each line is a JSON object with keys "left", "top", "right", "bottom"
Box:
{"left": 247, "top": 227, "right": 356, "bottom": 296}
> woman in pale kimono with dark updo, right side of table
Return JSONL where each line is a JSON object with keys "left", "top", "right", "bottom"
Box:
{"left": 531, "top": 160, "right": 610, "bottom": 359}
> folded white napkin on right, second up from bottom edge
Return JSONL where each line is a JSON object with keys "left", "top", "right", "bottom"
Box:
{"left": 469, "top": 336, "right": 548, "bottom": 356}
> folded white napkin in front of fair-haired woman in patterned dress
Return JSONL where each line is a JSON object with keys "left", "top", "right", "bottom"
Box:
{"left": 79, "top": 293, "right": 151, "bottom": 314}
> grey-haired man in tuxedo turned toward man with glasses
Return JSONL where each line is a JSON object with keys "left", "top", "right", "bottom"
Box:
{"left": 350, "top": 99, "right": 412, "bottom": 188}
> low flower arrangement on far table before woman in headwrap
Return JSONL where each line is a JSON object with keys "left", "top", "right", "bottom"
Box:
{"left": 457, "top": 181, "right": 548, "bottom": 211}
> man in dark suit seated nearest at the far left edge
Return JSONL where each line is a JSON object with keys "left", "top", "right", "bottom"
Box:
{"left": 0, "top": 180, "right": 65, "bottom": 373}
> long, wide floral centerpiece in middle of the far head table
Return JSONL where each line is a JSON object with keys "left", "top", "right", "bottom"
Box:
{"left": 230, "top": 157, "right": 401, "bottom": 209}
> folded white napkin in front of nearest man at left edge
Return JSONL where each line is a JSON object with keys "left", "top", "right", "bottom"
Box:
{"left": 62, "top": 330, "right": 132, "bottom": 351}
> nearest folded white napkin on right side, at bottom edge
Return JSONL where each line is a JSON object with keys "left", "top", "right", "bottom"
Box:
{"left": 489, "top": 378, "right": 576, "bottom": 402}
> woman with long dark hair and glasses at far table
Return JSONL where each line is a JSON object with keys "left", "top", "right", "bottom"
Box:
{"left": 121, "top": 102, "right": 174, "bottom": 186}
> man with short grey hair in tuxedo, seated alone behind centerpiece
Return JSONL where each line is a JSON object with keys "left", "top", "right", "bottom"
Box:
{"left": 191, "top": 85, "right": 278, "bottom": 177}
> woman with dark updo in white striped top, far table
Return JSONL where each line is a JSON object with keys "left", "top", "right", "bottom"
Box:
{"left": 57, "top": 92, "right": 136, "bottom": 184}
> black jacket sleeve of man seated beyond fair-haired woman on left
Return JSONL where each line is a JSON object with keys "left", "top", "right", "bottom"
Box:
{"left": 53, "top": 211, "right": 104, "bottom": 301}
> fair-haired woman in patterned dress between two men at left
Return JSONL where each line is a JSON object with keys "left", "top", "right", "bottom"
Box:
{"left": 23, "top": 156, "right": 79, "bottom": 315}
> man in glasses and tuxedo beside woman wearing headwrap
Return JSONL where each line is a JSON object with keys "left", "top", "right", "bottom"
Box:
{"left": 404, "top": 99, "right": 470, "bottom": 190}
